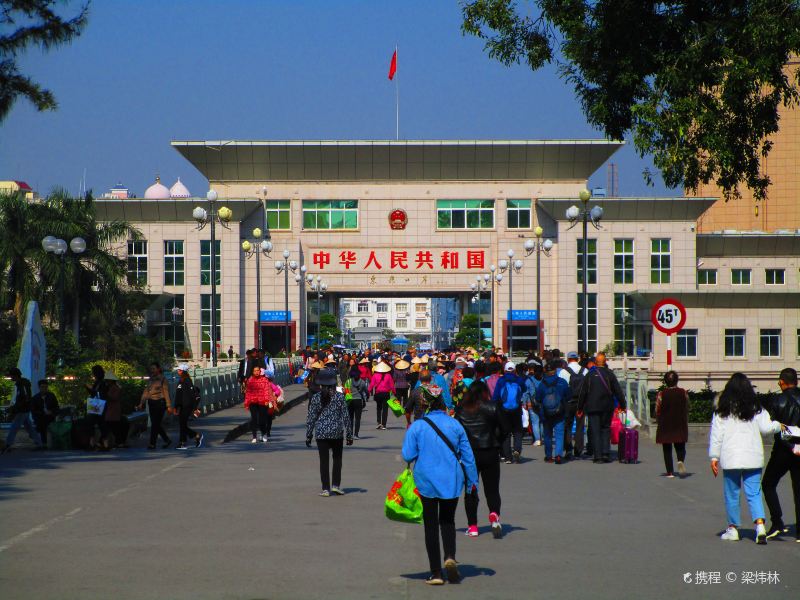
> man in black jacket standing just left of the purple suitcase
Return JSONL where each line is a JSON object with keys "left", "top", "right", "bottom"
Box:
{"left": 577, "top": 352, "right": 626, "bottom": 463}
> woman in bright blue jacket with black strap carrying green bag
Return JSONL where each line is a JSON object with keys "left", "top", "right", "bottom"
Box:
{"left": 403, "top": 385, "right": 478, "bottom": 585}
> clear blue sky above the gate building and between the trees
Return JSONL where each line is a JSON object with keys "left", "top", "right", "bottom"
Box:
{"left": 0, "top": 0, "right": 680, "bottom": 196}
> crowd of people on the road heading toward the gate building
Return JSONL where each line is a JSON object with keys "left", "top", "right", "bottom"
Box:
{"left": 6, "top": 347, "right": 800, "bottom": 585}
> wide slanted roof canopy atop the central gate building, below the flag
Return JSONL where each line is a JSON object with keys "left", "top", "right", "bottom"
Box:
{"left": 172, "top": 140, "right": 624, "bottom": 182}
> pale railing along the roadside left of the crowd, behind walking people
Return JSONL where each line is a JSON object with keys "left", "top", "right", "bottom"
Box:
{"left": 164, "top": 358, "right": 303, "bottom": 415}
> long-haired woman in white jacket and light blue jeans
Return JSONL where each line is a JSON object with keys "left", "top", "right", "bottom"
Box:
{"left": 708, "top": 373, "right": 782, "bottom": 544}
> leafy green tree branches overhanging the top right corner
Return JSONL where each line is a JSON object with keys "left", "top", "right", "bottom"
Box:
{"left": 462, "top": 0, "right": 800, "bottom": 199}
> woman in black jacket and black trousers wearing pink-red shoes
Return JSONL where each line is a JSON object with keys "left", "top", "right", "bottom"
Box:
{"left": 455, "top": 381, "right": 503, "bottom": 538}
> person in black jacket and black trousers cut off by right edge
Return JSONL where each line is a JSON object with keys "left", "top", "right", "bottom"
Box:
{"left": 761, "top": 369, "right": 800, "bottom": 542}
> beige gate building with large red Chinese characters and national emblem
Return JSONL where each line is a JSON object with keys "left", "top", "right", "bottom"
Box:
{"left": 98, "top": 140, "right": 800, "bottom": 388}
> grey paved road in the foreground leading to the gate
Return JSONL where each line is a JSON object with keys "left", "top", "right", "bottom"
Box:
{"left": 0, "top": 386, "right": 800, "bottom": 600}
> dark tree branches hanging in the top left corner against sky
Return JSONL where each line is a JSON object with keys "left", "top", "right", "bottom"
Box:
{"left": 0, "top": 0, "right": 89, "bottom": 123}
